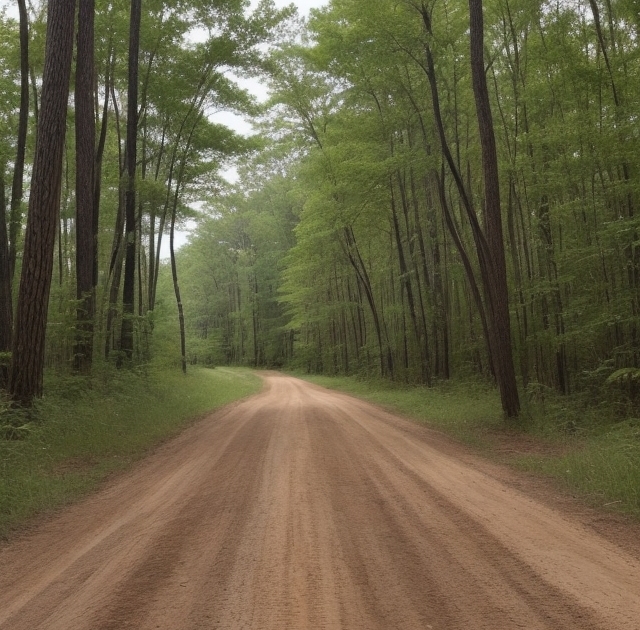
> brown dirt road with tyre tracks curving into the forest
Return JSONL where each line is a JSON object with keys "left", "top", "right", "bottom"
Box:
{"left": 0, "top": 375, "right": 640, "bottom": 630}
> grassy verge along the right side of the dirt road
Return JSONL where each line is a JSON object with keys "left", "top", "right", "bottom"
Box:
{"left": 296, "top": 374, "right": 640, "bottom": 519}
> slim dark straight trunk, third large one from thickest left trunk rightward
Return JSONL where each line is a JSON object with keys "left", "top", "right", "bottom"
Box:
{"left": 120, "top": 0, "right": 142, "bottom": 360}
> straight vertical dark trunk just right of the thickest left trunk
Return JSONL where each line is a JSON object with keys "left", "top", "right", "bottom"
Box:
{"left": 74, "top": 0, "right": 96, "bottom": 373}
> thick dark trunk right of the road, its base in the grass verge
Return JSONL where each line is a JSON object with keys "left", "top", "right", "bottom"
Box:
{"left": 469, "top": 0, "right": 520, "bottom": 418}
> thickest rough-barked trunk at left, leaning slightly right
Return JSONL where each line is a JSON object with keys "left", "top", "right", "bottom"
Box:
{"left": 9, "top": 0, "right": 75, "bottom": 405}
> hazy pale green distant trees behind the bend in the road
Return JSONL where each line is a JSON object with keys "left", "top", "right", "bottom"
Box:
{"left": 154, "top": 167, "right": 302, "bottom": 367}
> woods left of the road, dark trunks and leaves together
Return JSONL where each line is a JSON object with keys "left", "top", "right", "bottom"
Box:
{"left": 0, "top": 0, "right": 289, "bottom": 406}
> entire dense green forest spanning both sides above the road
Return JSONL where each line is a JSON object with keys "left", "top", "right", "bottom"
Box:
{"left": 0, "top": 0, "right": 640, "bottom": 417}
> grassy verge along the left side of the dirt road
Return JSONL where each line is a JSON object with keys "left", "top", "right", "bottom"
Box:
{"left": 0, "top": 368, "right": 261, "bottom": 539}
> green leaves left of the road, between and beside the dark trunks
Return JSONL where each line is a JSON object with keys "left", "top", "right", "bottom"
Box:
{"left": 0, "top": 0, "right": 292, "bottom": 386}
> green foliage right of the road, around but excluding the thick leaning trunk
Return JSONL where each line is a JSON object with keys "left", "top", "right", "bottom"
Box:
{"left": 245, "top": 0, "right": 640, "bottom": 404}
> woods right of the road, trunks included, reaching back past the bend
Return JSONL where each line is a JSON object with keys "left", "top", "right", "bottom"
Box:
{"left": 169, "top": 0, "right": 640, "bottom": 417}
